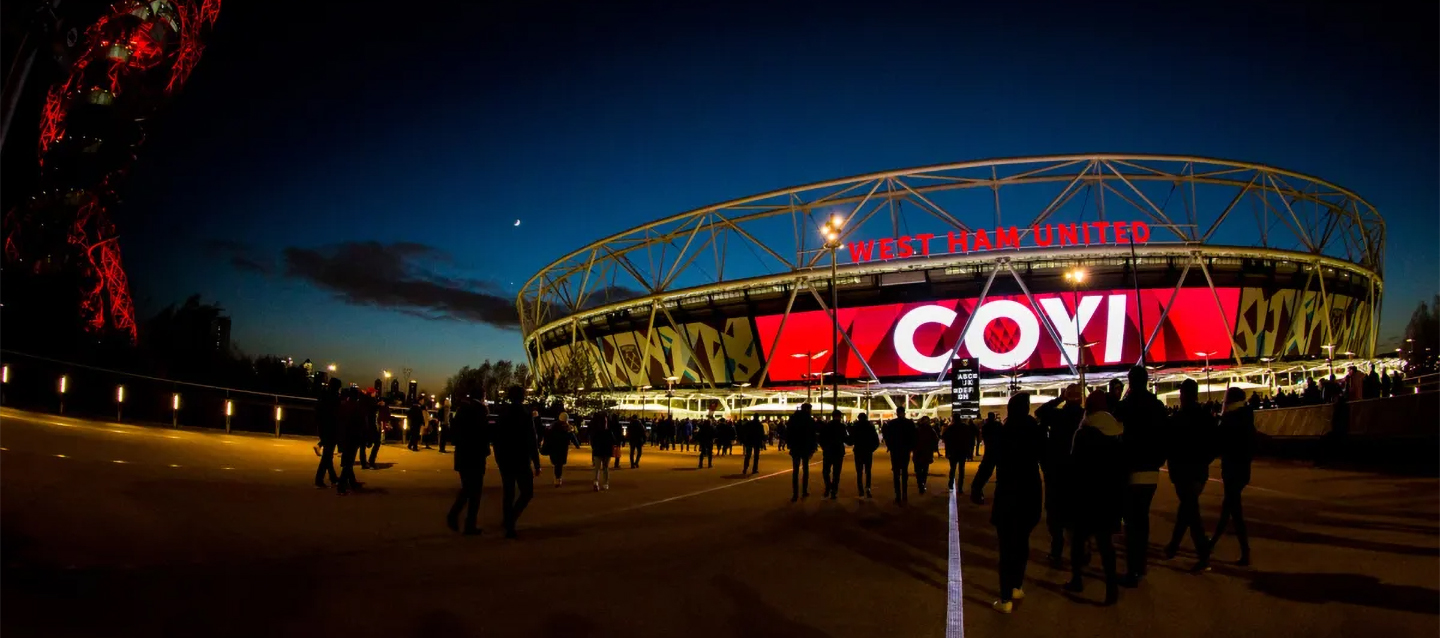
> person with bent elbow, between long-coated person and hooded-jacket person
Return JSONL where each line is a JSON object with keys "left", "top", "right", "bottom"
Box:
{"left": 1035, "top": 383, "right": 1084, "bottom": 569}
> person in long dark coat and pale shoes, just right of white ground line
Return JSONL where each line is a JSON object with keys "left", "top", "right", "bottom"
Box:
{"left": 991, "top": 392, "right": 1045, "bottom": 614}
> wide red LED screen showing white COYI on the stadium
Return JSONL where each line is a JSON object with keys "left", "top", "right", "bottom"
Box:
{"left": 755, "top": 288, "right": 1240, "bottom": 382}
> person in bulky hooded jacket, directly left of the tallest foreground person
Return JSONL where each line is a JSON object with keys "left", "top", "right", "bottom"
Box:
{"left": 1066, "top": 389, "right": 1129, "bottom": 605}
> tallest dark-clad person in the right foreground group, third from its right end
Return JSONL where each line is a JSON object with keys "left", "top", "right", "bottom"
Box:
{"left": 1112, "top": 366, "right": 1166, "bottom": 588}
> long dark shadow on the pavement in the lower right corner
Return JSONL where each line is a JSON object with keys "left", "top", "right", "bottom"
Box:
{"left": 1250, "top": 572, "right": 1440, "bottom": 615}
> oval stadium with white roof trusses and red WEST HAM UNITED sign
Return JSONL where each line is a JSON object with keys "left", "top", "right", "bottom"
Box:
{"left": 516, "top": 154, "right": 1385, "bottom": 416}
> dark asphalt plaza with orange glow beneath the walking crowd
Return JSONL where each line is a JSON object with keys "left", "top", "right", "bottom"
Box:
{"left": 0, "top": 409, "right": 1440, "bottom": 638}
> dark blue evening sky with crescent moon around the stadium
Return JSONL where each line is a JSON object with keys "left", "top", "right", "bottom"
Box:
{"left": 121, "top": 1, "right": 1440, "bottom": 383}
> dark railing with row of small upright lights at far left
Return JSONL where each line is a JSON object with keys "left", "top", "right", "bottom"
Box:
{"left": 0, "top": 350, "right": 317, "bottom": 436}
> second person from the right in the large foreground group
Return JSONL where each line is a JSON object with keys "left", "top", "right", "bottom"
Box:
{"left": 1165, "top": 379, "right": 1215, "bottom": 572}
